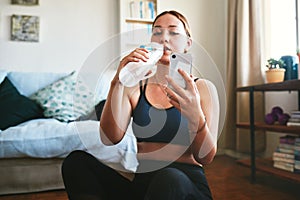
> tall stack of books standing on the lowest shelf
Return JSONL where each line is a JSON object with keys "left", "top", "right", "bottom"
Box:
{"left": 273, "top": 135, "right": 296, "bottom": 172}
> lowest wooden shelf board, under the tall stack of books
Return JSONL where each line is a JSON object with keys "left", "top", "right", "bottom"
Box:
{"left": 237, "top": 158, "right": 300, "bottom": 183}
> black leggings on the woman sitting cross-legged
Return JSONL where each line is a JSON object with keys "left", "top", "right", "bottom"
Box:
{"left": 62, "top": 151, "right": 212, "bottom": 200}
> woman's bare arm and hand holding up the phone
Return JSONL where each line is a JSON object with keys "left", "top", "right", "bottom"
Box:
{"left": 166, "top": 70, "right": 220, "bottom": 164}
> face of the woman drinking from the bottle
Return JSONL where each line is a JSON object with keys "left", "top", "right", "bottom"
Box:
{"left": 151, "top": 14, "right": 192, "bottom": 65}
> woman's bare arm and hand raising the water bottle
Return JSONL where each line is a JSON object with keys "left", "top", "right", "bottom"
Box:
{"left": 100, "top": 48, "right": 148, "bottom": 145}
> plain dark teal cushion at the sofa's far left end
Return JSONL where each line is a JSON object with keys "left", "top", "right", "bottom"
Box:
{"left": 0, "top": 78, "right": 44, "bottom": 130}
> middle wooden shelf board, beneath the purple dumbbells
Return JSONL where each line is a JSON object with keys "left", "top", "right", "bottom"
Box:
{"left": 236, "top": 122, "right": 300, "bottom": 135}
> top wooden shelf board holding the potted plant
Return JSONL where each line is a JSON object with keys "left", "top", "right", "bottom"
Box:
{"left": 236, "top": 79, "right": 300, "bottom": 92}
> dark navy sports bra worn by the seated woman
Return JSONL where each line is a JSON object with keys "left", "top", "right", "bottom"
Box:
{"left": 132, "top": 80, "right": 190, "bottom": 145}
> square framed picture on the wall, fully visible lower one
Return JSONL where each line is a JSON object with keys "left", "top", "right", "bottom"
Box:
{"left": 11, "top": 15, "right": 40, "bottom": 42}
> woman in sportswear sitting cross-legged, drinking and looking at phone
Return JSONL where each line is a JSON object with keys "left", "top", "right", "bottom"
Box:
{"left": 63, "top": 11, "right": 219, "bottom": 200}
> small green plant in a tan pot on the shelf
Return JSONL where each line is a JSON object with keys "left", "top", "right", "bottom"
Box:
{"left": 266, "top": 58, "right": 285, "bottom": 83}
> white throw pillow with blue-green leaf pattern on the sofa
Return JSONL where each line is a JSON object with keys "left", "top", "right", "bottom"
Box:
{"left": 30, "top": 72, "right": 96, "bottom": 122}
